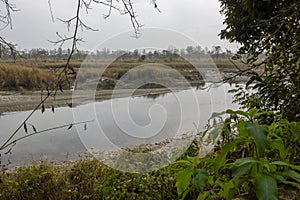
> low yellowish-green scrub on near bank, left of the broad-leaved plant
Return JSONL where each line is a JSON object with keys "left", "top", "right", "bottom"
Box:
{"left": 0, "top": 160, "right": 177, "bottom": 200}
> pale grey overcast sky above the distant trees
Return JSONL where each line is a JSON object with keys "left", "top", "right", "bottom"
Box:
{"left": 0, "top": 0, "right": 237, "bottom": 50}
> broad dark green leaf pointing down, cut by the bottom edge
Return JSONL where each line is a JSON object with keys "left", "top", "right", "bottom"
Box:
{"left": 255, "top": 173, "right": 278, "bottom": 200}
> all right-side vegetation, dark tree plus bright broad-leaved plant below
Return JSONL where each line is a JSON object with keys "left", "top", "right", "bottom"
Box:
{"left": 170, "top": 0, "right": 300, "bottom": 199}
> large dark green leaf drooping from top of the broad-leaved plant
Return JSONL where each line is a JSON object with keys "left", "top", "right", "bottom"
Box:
{"left": 245, "top": 122, "right": 268, "bottom": 157}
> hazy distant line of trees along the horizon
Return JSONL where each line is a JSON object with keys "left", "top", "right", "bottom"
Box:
{"left": 0, "top": 46, "right": 234, "bottom": 61}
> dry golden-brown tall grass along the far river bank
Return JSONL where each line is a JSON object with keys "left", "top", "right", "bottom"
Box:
{"left": 0, "top": 59, "right": 245, "bottom": 90}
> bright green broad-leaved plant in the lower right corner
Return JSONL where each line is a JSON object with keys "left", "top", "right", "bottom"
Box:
{"left": 173, "top": 108, "right": 300, "bottom": 199}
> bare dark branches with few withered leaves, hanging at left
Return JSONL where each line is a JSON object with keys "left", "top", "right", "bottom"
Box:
{"left": 0, "top": 0, "right": 162, "bottom": 151}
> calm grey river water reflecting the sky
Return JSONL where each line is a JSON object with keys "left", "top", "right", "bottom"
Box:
{"left": 0, "top": 84, "right": 237, "bottom": 164}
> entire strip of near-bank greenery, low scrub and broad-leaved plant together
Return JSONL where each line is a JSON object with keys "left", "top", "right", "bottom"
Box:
{"left": 0, "top": 109, "right": 300, "bottom": 199}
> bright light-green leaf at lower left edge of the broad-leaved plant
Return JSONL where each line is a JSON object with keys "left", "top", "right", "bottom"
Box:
{"left": 176, "top": 168, "right": 193, "bottom": 196}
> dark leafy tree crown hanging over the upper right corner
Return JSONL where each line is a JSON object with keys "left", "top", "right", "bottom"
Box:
{"left": 220, "top": 0, "right": 300, "bottom": 121}
